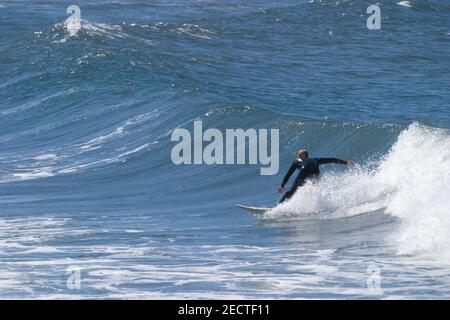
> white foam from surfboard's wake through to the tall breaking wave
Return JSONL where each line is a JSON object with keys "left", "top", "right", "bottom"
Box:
{"left": 265, "top": 123, "right": 450, "bottom": 262}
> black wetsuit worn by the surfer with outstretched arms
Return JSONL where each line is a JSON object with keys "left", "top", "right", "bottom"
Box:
{"left": 279, "top": 158, "right": 347, "bottom": 203}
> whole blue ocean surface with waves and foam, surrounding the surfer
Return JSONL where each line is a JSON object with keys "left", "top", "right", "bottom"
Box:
{"left": 0, "top": 0, "right": 450, "bottom": 299}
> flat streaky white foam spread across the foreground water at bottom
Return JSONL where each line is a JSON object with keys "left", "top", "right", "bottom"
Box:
{"left": 0, "top": 212, "right": 448, "bottom": 299}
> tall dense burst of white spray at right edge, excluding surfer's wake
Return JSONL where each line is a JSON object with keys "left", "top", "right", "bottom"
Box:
{"left": 376, "top": 123, "right": 450, "bottom": 259}
